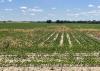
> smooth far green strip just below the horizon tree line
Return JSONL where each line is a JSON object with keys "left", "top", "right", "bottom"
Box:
{"left": 0, "top": 22, "right": 100, "bottom": 29}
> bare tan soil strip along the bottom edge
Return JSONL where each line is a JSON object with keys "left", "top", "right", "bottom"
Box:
{"left": 0, "top": 67, "right": 100, "bottom": 71}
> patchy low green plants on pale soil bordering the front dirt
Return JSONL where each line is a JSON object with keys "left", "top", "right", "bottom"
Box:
{"left": 0, "top": 53, "right": 100, "bottom": 67}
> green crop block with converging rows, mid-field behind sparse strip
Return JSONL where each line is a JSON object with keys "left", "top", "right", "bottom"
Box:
{"left": 0, "top": 31, "right": 100, "bottom": 53}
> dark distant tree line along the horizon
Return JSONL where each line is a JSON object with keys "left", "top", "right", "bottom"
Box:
{"left": 0, "top": 20, "right": 100, "bottom": 24}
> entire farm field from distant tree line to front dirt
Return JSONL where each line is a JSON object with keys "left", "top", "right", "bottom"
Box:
{"left": 0, "top": 23, "right": 100, "bottom": 71}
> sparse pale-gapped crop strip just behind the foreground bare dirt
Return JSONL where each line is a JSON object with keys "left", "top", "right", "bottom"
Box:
{"left": 0, "top": 53, "right": 100, "bottom": 67}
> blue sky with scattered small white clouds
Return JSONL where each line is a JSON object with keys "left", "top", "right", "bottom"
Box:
{"left": 0, "top": 0, "right": 100, "bottom": 21}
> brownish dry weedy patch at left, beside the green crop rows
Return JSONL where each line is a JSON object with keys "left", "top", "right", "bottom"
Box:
{"left": 0, "top": 36, "right": 33, "bottom": 48}
